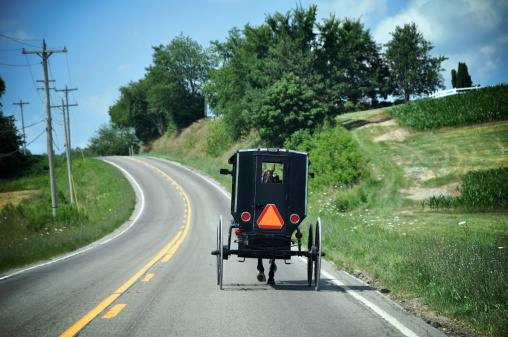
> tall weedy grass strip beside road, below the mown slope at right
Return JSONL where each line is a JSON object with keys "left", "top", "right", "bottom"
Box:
{"left": 309, "top": 201, "right": 508, "bottom": 335}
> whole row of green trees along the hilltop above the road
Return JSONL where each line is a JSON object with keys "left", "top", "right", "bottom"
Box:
{"left": 91, "top": 5, "right": 446, "bottom": 148}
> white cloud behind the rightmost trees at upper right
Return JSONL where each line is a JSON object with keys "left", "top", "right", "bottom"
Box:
{"left": 373, "top": 0, "right": 508, "bottom": 88}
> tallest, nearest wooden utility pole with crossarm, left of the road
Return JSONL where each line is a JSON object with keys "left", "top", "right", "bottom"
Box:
{"left": 21, "top": 40, "right": 67, "bottom": 216}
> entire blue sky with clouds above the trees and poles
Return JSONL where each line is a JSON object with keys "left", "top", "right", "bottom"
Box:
{"left": 0, "top": 0, "right": 508, "bottom": 154}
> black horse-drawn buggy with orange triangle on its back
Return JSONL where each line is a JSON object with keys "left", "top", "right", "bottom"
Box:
{"left": 212, "top": 149, "right": 325, "bottom": 290}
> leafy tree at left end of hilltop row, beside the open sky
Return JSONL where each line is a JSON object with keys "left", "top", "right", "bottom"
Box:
{"left": 109, "top": 34, "right": 215, "bottom": 143}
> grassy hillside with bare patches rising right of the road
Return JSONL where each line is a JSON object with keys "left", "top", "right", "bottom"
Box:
{"left": 144, "top": 105, "right": 508, "bottom": 335}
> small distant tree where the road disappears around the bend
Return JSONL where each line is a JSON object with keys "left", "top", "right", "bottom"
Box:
{"left": 88, "top": 122, "right": 139, "bottom": 156}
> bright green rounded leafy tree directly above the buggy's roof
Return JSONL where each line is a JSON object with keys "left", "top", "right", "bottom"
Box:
{"left": 256, "top": 73, "right": 326, "bottom": 146}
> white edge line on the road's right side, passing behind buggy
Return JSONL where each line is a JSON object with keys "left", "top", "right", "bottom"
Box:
{"left": 151, "top": 157, "right": 418, "bottom": 337}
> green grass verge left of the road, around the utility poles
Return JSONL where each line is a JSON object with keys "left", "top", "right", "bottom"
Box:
{"left": 0, "top": 156, "right": 135, "bottom": 272}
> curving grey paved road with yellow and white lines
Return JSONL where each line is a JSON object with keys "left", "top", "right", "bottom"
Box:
{"left": 0, "top": 157, "right": 443, "bottom": 337}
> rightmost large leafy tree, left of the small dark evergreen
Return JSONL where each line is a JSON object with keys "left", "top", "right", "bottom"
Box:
{"left": 385, "top": 23, "right": 448, "bottom": 102}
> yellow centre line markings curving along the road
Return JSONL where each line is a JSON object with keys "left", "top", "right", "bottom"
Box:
{"left": 60, "top": 158, "right": 191, "bottom": 337}
